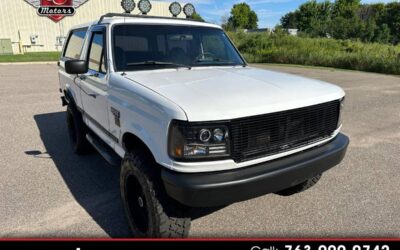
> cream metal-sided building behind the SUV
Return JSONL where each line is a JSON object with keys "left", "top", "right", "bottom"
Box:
{"left": 0, "top": 0, "right": 184, "bottom": 54}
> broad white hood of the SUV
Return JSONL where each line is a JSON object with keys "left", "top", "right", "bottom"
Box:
{"left": 126, "top": 67, "right": 345, "bottom": 121}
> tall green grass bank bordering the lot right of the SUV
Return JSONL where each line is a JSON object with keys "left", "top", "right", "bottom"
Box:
{"left": 229, "top": 32, "right": 400, "bottom": 75}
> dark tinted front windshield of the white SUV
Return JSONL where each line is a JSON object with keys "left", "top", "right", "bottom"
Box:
{"left": 113, "top": 24, "right": 245, "bottom": 71}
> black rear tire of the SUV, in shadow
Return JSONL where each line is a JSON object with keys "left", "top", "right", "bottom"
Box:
{"left": 67, "top": 104, "right": 92, "bottom": 155}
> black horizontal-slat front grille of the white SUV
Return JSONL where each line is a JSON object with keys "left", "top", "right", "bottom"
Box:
{"left": 230, "top": 101, "right": 340, "bottom": 162}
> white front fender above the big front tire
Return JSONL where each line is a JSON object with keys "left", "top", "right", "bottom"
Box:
{"left": 109, "top": 73, "right": 187, "bottom": 169}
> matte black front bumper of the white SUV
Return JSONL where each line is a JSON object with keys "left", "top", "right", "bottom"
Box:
{"left": 161, "top": 134, "right": 349, "bottom": 207}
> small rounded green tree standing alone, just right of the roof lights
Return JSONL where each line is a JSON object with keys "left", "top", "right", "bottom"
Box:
{"left": 226, "top": 3, "right": 258, "bottom": 29}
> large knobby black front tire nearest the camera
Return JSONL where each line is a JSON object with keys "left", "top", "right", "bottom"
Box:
{"left": 120, "top": 152, "right": 191, "bottom": 238}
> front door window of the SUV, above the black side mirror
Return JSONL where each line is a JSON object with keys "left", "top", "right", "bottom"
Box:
{"left": 88, "top": 32, "right": 106, "bottom": 73}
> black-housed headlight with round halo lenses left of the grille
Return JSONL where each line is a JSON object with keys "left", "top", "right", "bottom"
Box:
{"left": 168, "top": 121, "right": 230, "bottom": 161}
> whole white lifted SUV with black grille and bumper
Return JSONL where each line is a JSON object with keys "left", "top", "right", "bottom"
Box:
{"left": 59, "top": 14, "right": 349, "bottom": 237}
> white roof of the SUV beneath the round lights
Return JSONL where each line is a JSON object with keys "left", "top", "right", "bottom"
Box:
{"left": 72, "top": 16, "right": 221, "bottom": 29}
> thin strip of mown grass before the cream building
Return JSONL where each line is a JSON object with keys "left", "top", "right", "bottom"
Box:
{"left": 0, "top": 52, "right": 60, "bottom": 63}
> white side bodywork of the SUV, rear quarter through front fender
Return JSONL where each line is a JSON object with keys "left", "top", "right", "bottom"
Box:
{"left": 59, "top": 25, "right": 187, "bottom": 169}
